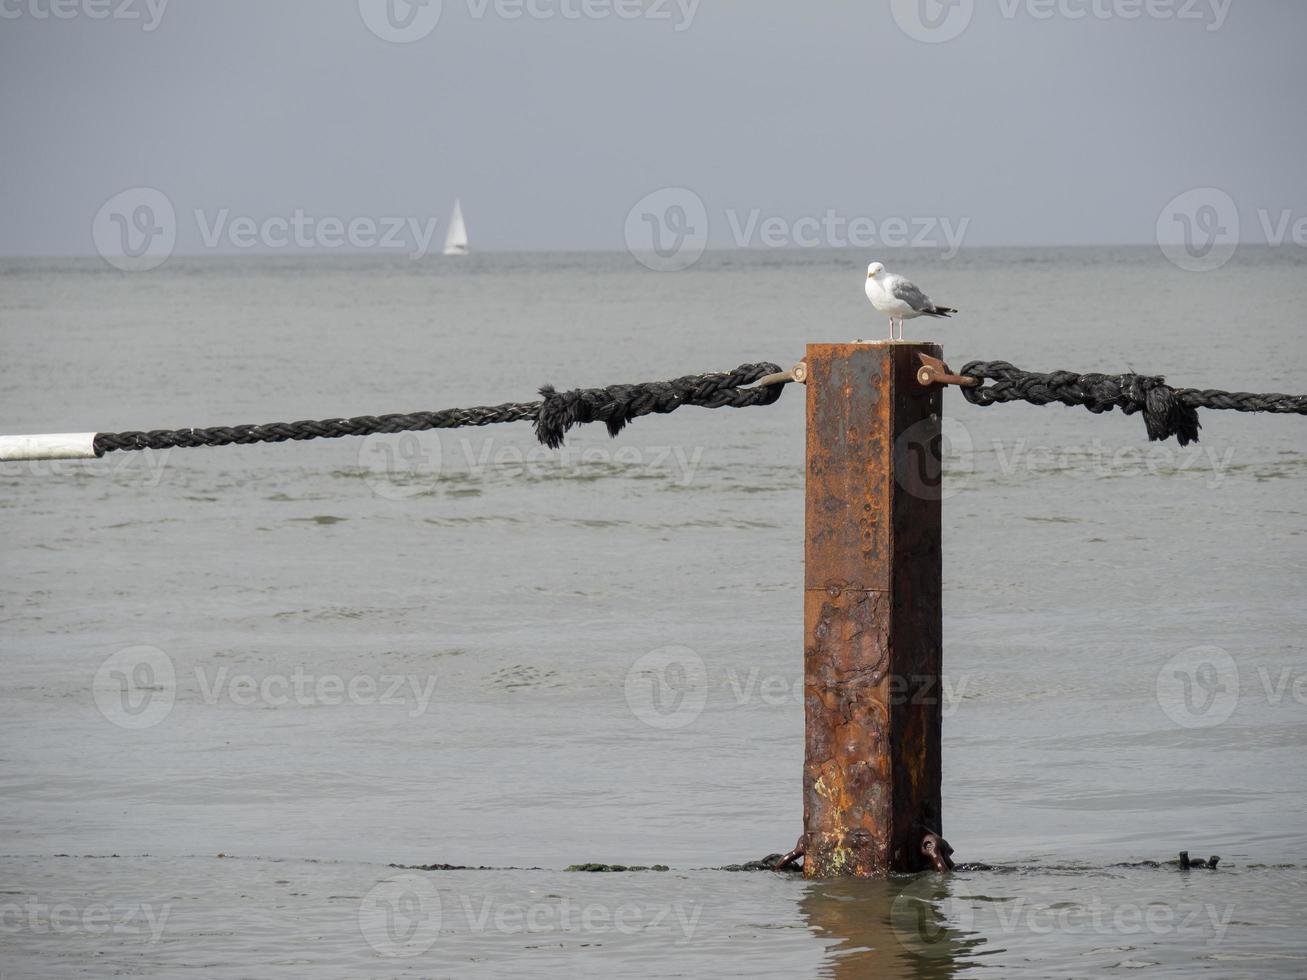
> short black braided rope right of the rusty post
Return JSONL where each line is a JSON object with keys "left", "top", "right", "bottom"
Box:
{"left": 961, "top": 361, "right": 1307, "bottom": 446}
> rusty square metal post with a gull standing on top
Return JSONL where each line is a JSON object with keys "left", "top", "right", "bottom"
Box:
{"left": 804, "top": 342, "right": 942, "bottom": 878}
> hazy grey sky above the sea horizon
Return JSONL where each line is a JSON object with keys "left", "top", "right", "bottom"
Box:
{"left": 0, "top": 0, "right": 1307, "bottom": 255}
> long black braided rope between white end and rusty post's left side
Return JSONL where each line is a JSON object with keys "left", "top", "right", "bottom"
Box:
{"left": 93, "top": 363, "right": 786, "bottom": 456}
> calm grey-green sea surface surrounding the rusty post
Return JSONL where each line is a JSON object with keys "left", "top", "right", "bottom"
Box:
{"left": 0, "top": 248, "right": 1307, "bottom": 980}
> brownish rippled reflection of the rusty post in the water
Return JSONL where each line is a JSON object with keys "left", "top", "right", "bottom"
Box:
{"left": 799, "top": 872, "right": 984, "bottom": 980}
